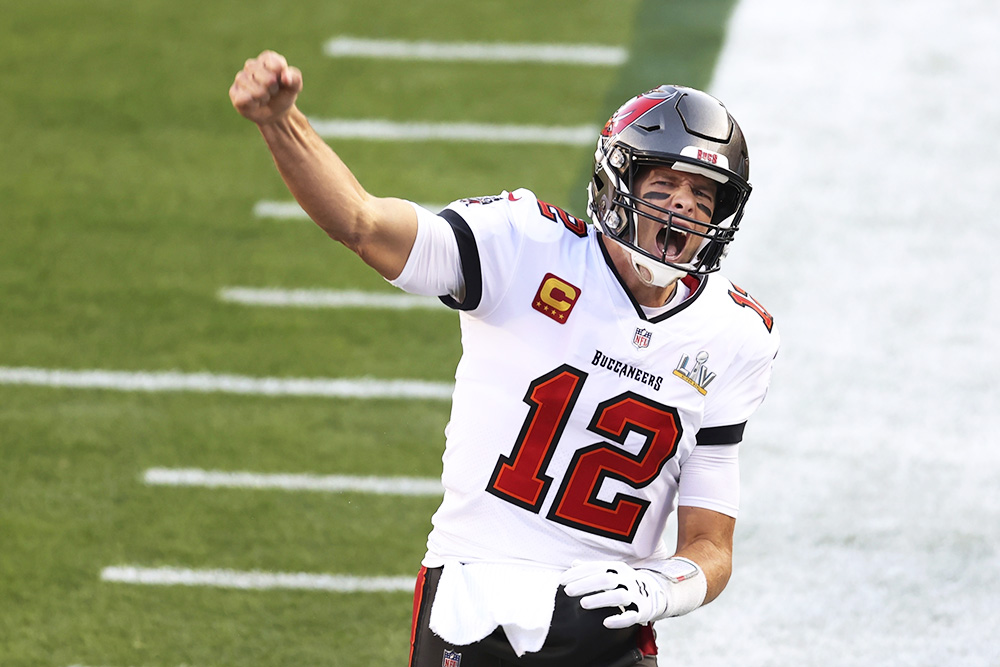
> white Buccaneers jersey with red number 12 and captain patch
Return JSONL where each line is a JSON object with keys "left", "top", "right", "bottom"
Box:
{"left": 394, "top": 190, "right": 778, "bottom": 569}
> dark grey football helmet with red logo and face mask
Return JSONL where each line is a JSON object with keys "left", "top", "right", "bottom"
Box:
{"left": 587, "top": 86, "right": 751, "bottom": 287}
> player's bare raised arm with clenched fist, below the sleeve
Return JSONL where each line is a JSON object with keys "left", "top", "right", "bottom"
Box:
{"left": 229, "top": 51, "right": 417, "bottom": 280}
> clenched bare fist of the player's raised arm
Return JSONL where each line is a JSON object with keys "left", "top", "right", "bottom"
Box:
{"left": 229, "top": 51, "right": 302, "bottom": 125}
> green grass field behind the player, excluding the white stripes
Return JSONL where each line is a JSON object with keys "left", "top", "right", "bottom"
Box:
{"left": 0, "top": 0, "right": 732, "bottom": 667}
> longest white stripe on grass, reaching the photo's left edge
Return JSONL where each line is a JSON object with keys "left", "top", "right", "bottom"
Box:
{"left": 0, "top": 366, "right": 454, "bottom": 401}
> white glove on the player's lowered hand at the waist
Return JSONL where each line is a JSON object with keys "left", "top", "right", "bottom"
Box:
{"left": 560, "top": 557, "right": 707, "bottom": 630}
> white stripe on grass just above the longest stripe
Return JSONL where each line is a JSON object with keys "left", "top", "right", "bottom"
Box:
{"left": 219, "top": 287, "right": 454, "bottom": 312}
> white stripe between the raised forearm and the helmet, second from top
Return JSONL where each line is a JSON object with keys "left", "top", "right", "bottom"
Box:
{"left": 309, "top": 118, "right": 601, "bottom": 146}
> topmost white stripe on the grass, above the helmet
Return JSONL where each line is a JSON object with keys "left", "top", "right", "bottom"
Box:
{"left": 323, "top": 36, "right": 628, "bottom": 67}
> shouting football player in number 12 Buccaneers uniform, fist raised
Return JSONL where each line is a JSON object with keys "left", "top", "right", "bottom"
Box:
{"left": 230, "top": 52, "right": 778, "bottom": 667}
